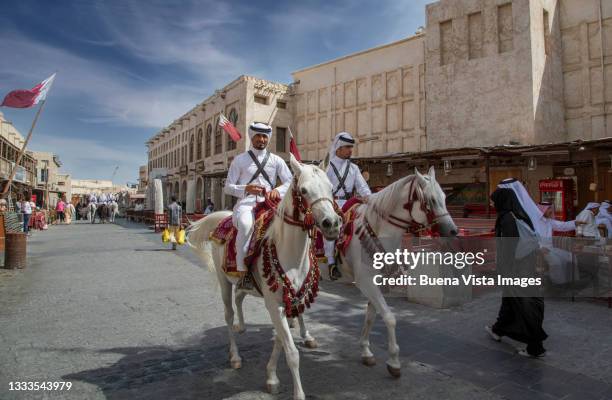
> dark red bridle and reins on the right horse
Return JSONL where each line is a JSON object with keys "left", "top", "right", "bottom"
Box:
{"left": 372, "top": 178, "right": 450, "bottom": 235}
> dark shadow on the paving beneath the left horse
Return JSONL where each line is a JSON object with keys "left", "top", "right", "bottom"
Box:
{"left": 63, "top": 325, "right": 412, "bottom": 399}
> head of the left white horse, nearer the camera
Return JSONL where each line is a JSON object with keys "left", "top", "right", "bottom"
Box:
{"left": 287, "top": 155, "right": 342, "bottom": 240}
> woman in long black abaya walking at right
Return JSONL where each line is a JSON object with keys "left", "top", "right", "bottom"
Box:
{"left": 486, "top": 188, "right": 548, "bottom": 357}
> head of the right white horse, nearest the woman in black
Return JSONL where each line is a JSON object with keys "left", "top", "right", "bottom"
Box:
{"left": 409, "top": 166, "right": 457, "bottom": 236}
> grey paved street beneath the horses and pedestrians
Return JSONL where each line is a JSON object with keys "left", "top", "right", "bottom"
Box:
{"left": 0, "top": 220, "right": 612, "bottom": 400}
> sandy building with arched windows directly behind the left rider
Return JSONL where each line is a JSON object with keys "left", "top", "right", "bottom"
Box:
{"left": 147, "top": 75, "right": 291, "bottom": 212}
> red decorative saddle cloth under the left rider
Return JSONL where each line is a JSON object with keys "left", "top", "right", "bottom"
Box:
{"left": 210, "top": 200, "right": 278, "bottom": 277}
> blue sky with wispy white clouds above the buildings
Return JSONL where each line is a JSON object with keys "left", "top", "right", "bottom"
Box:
{"left": 0, "top": 0, "right": 431, "bottom": 183}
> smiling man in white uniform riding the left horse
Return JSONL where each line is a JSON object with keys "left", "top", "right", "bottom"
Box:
{"left": 224, "top": 122, "right": 292, "bottom": 284}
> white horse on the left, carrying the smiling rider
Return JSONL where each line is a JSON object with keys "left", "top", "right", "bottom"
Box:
{"left": 188, "top": 156, "right": 342, "bottom": 399}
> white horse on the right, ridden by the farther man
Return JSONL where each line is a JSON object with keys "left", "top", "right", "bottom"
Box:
{"left": 236, "top": 167, "right": 457, "bottom": 378}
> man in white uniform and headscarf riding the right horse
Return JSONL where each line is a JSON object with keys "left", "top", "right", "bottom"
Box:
{"left": 325, "top": 132, "right": 372, "bottom": 279}
